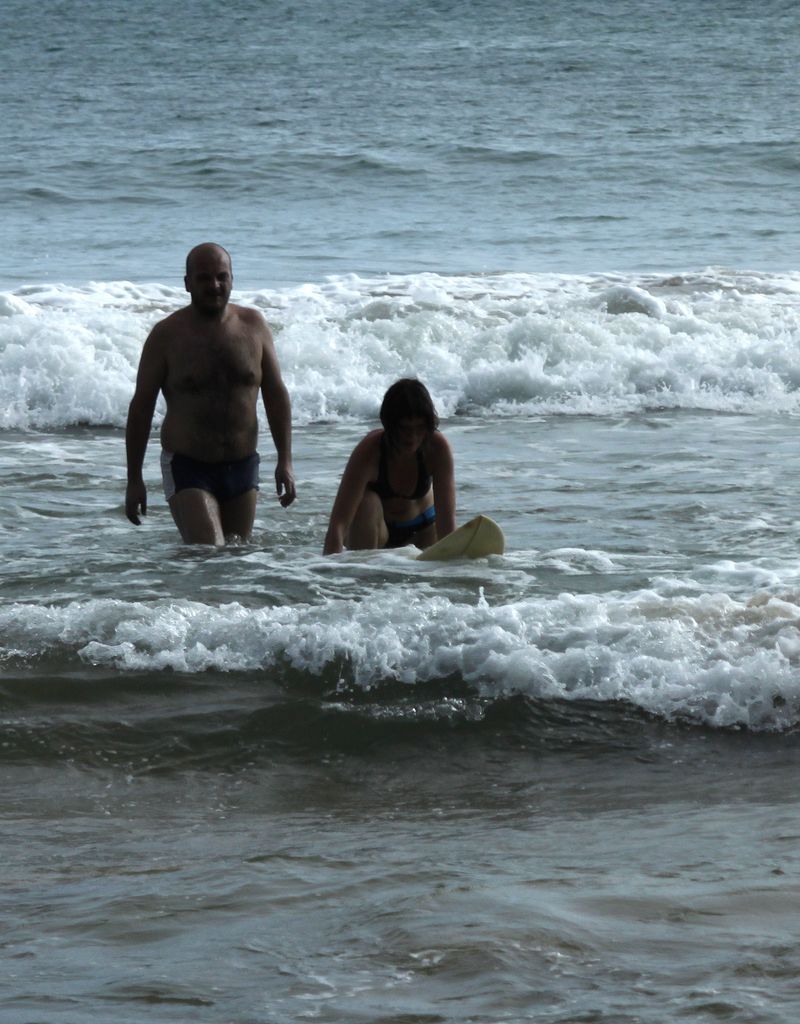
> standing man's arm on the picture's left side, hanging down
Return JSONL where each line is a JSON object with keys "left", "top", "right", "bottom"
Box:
{"left": 125, "top": 324, "right": 166, "bottom": 526}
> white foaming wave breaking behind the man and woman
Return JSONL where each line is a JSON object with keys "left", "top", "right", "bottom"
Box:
{"left": 0, "top": 270, "right": 800, "bottom": 429}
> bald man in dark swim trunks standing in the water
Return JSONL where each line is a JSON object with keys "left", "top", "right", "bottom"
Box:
{"left": 125, "top": 243, "right": 295, "bottom": 545}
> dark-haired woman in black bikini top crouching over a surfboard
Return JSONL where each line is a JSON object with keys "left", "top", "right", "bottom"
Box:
{"left": 323, "top": 378, "right": 456, "bottom": 555}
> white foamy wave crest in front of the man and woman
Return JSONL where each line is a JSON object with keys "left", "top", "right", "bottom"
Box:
{"left": 0, "top": 587, "right": 800, "bottom": 730}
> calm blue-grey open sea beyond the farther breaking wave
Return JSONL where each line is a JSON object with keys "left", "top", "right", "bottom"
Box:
{"left": 0, "top": 0, "right": 800, "bottom": 287}
